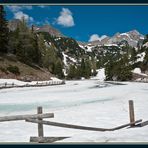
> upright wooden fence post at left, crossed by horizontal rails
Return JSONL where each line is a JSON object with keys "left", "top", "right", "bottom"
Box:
{"left": 37, "top": 106, "right": 44, "bottom": 137}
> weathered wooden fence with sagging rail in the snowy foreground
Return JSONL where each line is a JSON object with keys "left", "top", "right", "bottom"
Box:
{"left": 0, "top": 100, "right": 148, "bottom": 143}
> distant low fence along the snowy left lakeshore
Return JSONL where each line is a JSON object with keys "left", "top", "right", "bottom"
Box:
{"left": 0, "top": 80, "right": 65, "bottom": 89}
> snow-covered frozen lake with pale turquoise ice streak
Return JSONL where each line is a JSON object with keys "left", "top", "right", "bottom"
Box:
{"left": 0, "top": 80, "right": 148, "bottom": 142}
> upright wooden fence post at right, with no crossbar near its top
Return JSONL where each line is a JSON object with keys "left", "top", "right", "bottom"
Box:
{"left": 129, "top": 100, "right": 135, "bottom": 127}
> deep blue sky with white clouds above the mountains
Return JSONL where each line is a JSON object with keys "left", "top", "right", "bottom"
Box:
{"left": 5, "top": 5, "right": 148, "bottom": 42}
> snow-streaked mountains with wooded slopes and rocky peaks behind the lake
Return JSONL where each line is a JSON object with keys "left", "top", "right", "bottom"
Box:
{"left": 5, "top": 18, "right": 148, "bottom": 80}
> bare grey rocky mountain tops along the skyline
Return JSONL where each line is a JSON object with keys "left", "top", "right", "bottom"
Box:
{"left": 8, "top": 19, "right": 144, "bottom": 47}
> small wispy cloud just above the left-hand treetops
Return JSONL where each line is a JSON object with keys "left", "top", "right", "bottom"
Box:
{"left": 14, "top": 11, "right": 34, "bottom": 22}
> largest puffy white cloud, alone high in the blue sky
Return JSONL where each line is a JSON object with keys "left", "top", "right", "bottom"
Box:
{"left": 56, "top": 8, "right": 75, "bottom": 27}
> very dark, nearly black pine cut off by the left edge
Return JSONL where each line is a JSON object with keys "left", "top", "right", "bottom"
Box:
{"left": 0, "top": 5, "right": 9, "bottom": 53}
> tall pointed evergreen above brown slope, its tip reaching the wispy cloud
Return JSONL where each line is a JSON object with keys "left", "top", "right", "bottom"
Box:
{"left": 16, "top": 17, "right": 41, "bottom": 65}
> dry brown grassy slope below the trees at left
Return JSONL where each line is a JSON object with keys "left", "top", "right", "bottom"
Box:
{"left": 0, "top": 55, "right": 51, "bottom": 81}
